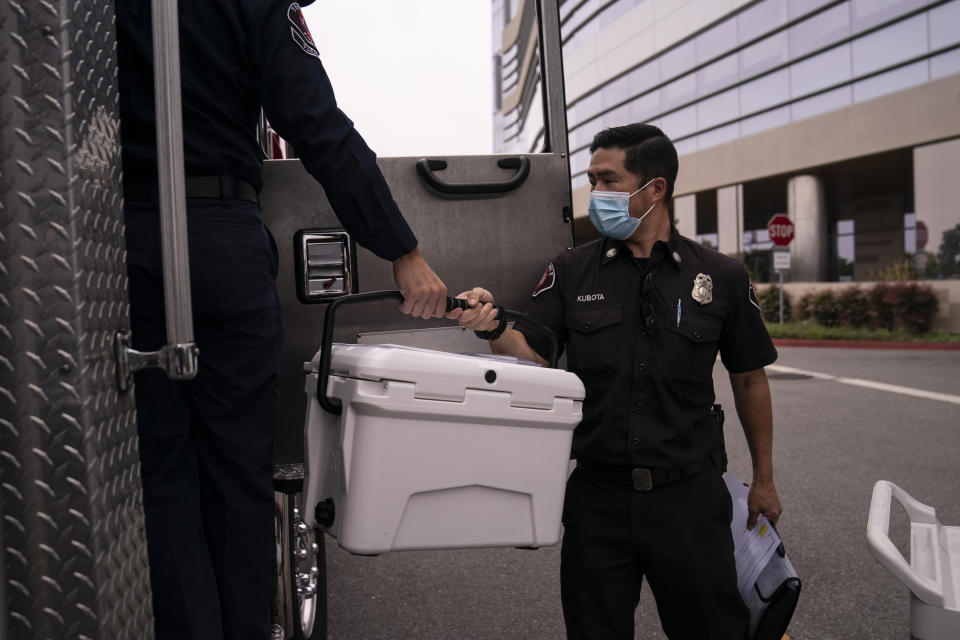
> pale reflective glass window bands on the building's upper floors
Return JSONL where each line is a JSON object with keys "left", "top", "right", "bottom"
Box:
{"left": 494, "top": 0, "right": 960, "bottom": 182}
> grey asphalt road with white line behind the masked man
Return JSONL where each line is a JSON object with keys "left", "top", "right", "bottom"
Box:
{"left": 326, "top": 347, "right": 960, "bottom": 640}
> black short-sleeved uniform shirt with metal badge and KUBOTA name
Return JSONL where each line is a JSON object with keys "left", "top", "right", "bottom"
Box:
{"left": 516, "top": 229, "right": 777, "bottom": 469}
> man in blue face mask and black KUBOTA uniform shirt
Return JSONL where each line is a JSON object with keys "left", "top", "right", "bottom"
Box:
{"left": 448, "top": 124, "right": 781, "bottom": 640}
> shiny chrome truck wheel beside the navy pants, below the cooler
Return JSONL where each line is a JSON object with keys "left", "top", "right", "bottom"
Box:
{"left": 271, "top": 465, "right": 327, "bottom": 640}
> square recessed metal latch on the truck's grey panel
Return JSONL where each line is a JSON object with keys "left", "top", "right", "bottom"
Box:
{"left": 294, "top": 231, "right": 356, "bottom": 304}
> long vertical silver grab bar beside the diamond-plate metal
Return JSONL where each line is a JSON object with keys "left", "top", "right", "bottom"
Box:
{"left": 114, "top": 0, "right": 198, "bottom": 391}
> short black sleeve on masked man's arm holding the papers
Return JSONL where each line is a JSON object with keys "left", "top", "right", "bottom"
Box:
{"left": 720, "top": 265, "right": 777, "bottom": 373}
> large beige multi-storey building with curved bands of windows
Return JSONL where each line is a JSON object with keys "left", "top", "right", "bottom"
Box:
{"left": 492, "top": 0, "right": 960, "bottom": 282}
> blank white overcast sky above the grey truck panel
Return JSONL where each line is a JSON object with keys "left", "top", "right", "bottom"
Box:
{"left": 303, "top": 0, "right": 493, "bottom": 156}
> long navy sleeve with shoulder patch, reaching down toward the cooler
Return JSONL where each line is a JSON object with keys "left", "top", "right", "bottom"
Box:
{"left": 247, "top": 0, "right": 417, "bottom": 260}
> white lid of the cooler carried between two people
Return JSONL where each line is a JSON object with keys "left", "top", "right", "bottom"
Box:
{"left": 310, "top": 344, "right": 585, "bottom": 408}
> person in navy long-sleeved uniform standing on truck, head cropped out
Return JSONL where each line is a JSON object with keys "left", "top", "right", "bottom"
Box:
{"left": 115, "top": 0, "right": 446, "bottom": 640}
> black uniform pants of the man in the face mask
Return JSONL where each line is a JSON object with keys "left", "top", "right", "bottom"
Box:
{"left": 560, "top": 467, "right": 750, "bottom": 640}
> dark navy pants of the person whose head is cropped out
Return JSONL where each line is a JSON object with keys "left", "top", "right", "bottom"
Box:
{"left": 125, "top": 198, "right": 282, "bottom": 640}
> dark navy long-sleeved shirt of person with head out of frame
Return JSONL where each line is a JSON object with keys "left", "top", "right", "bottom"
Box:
{"left": 115, "top": 0, "right": 417, "bottom": 260}
